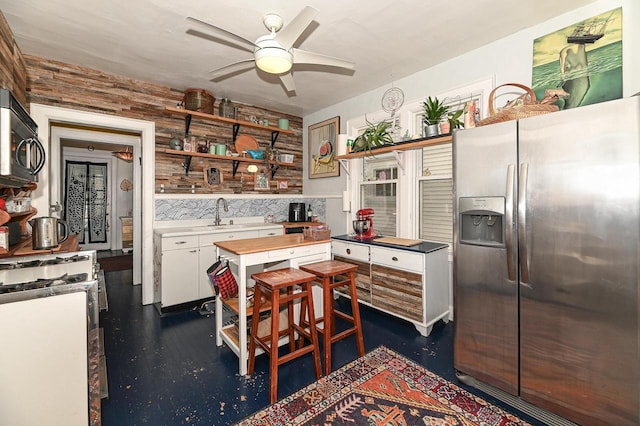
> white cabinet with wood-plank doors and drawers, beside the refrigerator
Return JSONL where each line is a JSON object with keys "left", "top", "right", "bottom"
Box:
{"left": 331, "top": 240, "right": 450, "bottom": 336}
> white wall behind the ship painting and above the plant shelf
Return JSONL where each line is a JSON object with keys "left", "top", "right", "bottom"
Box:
{"left": 302, "top": 0, "right": 640, "bottom": 208}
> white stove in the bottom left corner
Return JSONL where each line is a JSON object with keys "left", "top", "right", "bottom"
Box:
{"left": 0, "top": 251, "right": 100, "bottom": 425}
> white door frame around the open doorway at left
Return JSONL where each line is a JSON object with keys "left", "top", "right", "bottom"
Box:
{"left": 30, "top": 103, "right": 155, "bottom": 305}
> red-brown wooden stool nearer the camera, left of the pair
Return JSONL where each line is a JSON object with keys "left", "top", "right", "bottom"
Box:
{"left": 248, "top": 268, "right": 322, "bottom": 404}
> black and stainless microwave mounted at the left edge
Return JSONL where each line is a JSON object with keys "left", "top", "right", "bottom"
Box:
{"left": 0, "top": 89, "right": 45, "bottom": 188}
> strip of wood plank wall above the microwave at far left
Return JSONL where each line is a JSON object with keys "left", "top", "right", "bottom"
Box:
{"left": 0, "top": 11, "right": 29, "bottom": 105}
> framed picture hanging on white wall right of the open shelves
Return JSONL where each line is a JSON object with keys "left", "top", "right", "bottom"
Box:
{"left": 307, "top": 117, "right": 340, "bottom": 179}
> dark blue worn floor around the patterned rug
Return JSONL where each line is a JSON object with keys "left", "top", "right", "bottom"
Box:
{"left": 100, "top": 270, "right": 539, "bottom": 426}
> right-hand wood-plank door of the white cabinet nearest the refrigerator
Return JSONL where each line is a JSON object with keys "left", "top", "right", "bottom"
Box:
{"left": 371, "top": 265, "right": 424, "bottom": 322}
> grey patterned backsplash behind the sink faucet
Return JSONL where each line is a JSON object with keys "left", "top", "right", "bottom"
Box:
{"left": 156, "top": 198, "right": 326, "bottom": 222}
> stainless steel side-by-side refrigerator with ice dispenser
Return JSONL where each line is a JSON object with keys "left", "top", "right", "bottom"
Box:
{"left": 453, "top": 96, "right": 640, "bottom": 425}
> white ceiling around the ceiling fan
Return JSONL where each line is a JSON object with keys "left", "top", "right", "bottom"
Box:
{"left": 0, "top": 0, "right": 596, "bottom": 116}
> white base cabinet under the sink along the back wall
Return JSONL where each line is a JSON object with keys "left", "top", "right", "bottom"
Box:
{"left": 154, "top": 225, "right": 282, "bottom": 309}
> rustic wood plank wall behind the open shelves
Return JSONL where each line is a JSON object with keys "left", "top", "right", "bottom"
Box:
{"left": 25, "top": 55, "right": 302, "bottom": 194}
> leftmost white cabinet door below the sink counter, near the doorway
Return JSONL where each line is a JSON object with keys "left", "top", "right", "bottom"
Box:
{"left": 161, "top": 247, "right": 199, "bottom": 307}
